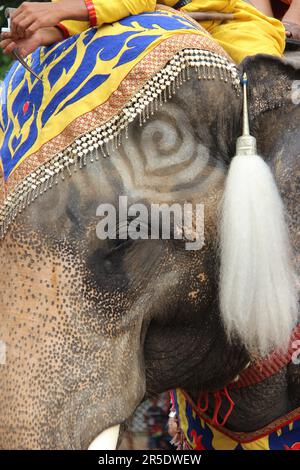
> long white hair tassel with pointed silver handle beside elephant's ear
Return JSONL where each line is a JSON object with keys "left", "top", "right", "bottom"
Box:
{"left": 220, "top": 76, "right": 297, "bottom": 355}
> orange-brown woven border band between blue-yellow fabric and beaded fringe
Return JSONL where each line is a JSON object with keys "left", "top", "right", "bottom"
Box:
{"left": 0, "top": 32, "right": 232, "bottom": 203}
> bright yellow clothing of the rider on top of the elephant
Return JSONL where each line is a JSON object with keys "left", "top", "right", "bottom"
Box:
{"left": 52, "top": 0, "right": 285, "bottom": 63}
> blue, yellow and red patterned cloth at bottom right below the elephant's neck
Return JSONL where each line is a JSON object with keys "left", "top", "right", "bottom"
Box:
{"left": 171, "top": 389, "right": 300, "bottom": 450}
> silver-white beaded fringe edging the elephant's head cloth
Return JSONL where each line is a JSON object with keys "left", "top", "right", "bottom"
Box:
{"left": 0, "top": 49, "right": 240, "bottom": 239}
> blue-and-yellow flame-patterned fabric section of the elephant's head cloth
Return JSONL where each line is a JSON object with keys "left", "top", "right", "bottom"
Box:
{"left": 0, "top": 11, "right": 208, "bottom": 181}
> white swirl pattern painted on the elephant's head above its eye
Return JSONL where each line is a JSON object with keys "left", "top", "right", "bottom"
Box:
{"left": 111, "top": 103, "right": 224, "bottom": 200}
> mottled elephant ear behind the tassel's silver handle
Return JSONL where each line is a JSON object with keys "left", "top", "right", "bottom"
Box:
{"left": 241, "top": 54, "right": 300, "bottom": 157}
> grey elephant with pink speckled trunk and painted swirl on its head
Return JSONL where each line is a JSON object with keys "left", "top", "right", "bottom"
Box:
{"left": 0, "top": 11, "right": 300, "bottom": 449}
